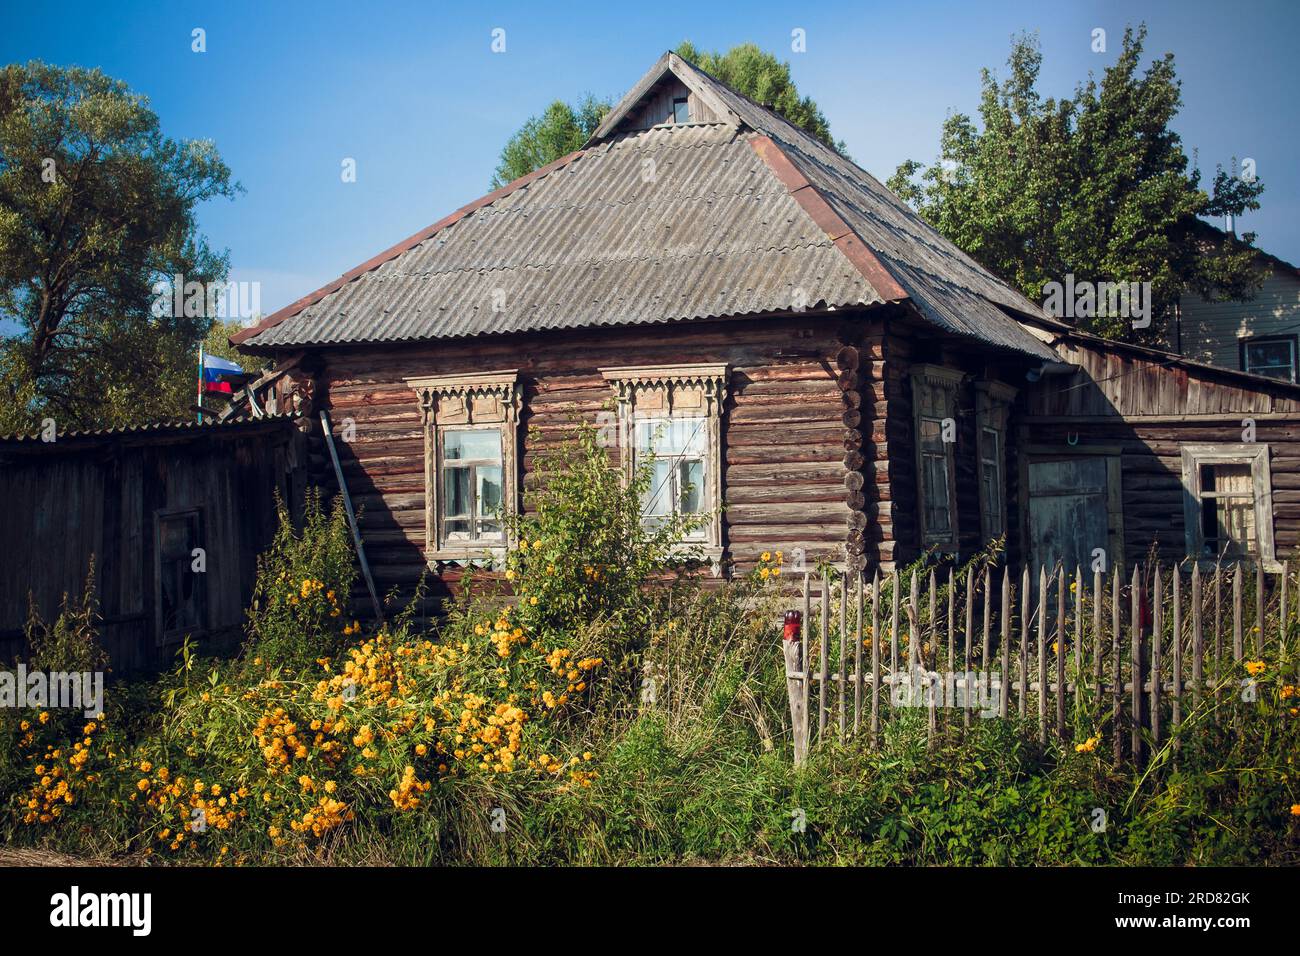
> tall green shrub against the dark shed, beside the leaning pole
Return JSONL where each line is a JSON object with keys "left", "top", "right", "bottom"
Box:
{"left": 248, "top": 489, "right": 358, "bottom": 667}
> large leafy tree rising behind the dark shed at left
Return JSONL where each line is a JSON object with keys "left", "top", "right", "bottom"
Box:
{"left": 0, "top": 61, "right": 239, "bottom": 431}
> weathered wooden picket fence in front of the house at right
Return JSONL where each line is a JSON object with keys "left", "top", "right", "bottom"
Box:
{"left": 783, "top": 561, "right": 1297, "bottom": 763}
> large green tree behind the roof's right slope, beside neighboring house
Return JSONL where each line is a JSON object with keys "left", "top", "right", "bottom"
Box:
{"left": 888, "top": 26, "right": 1264, "bottom": 342}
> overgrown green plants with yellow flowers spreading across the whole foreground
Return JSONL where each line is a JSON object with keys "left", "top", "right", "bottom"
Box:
{"left": 0, "top": 429, "right": 1300, "bottom": 866}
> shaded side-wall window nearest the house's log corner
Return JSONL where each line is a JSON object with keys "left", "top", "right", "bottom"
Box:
{"left": 911, "top": 365, "right": 962, "bottom": 550}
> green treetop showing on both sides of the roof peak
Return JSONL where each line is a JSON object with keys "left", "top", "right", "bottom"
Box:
{"left": 491, "top": 40, "right": 844, "bottom": 189}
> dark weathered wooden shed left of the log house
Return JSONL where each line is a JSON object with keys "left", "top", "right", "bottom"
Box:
{"left": 0, "top": 418, "right": 307, "bottom": 674}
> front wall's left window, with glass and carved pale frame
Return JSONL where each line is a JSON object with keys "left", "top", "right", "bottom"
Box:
{"left": 407, "top": 369, "right": 523, "bottom": 563}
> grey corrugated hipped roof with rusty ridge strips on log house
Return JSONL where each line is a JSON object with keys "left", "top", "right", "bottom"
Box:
{"left": 234, "top": 55, "right": 1056, "bottom": 360}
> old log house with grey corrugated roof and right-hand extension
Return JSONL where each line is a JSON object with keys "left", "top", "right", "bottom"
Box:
{"left": 205, "top": 53, "right": 1300, "bottom": 613}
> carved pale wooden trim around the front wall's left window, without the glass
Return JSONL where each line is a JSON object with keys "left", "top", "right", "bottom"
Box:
{"left": 404, "top": 368, "right": 524, "bottom": 566}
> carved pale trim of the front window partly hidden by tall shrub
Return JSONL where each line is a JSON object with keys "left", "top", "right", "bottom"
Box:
{"left": 599, "top": 363, "right": 731, "bottom": 566}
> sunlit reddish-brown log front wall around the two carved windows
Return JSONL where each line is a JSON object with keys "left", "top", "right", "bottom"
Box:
{"left": 313, "top": 315, "right": 889, "bottom": 600}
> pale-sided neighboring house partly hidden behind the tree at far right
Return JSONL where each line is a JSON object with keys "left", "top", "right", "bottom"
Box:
{"left": 1164, "top": 264, "right": 1300, "bottom": 371}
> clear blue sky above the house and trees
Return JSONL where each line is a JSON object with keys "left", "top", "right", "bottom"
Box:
{"left": 0, "top": 0, "right": 1300, "bottom": 321}
